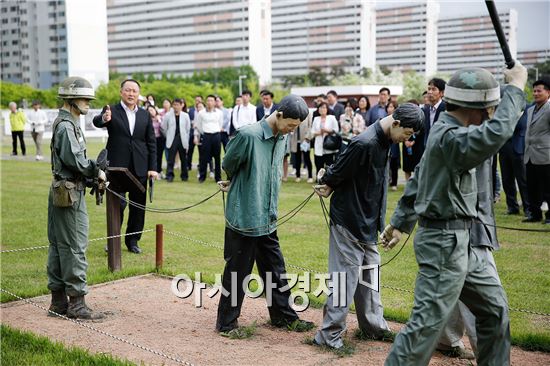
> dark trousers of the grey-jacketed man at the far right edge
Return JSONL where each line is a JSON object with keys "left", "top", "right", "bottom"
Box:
{"left": 526, "top": 162, "right": 550, "bottom": 219}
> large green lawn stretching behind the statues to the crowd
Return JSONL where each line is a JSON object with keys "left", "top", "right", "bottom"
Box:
{"left": 1, "top": 137, "right": 550, "bottom": 352}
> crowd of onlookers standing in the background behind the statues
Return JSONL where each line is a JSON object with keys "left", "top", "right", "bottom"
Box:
{"left": 9, "top": 77, "right": 550, "bottom": 223}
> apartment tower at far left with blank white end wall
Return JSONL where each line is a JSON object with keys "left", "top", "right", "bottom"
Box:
{"left": 0, "top": 0, "right": 108, "bottom": 89}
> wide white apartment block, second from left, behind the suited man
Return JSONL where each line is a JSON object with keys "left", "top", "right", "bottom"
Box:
{"left": 107, "top": 0, "right": 271, "bottom": 82}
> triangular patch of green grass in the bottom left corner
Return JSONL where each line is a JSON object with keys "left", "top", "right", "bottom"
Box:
{"left": 0, "top": 325, "right": 135, "bottom": 366}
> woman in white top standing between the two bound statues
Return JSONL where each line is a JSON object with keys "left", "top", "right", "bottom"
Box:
{"left": 311, "top": 102, "right": 339, "bottom": 172}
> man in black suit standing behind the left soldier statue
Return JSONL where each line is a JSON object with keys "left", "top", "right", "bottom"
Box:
{"left": 93, "top": 79, "right": 158, "bottom": 254}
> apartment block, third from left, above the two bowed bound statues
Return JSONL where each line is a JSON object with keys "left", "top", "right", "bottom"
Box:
{"left": 272, "top": 0, "right": 376, "bottom": 79}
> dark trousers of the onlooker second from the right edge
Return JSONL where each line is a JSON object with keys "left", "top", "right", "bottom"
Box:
{"left": 498, "top": 142, "right": 529, "bottom": 213}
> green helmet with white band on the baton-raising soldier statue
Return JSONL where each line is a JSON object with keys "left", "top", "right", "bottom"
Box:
{"left": 443, "top": 67, "right": 500, "bottom": 109}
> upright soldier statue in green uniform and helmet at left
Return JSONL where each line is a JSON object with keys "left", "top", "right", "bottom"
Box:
{"left": 48, "top": 77, "right": 106, "bottom": 319}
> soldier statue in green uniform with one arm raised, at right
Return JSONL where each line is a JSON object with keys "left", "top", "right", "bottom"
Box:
{"left": 380, "top": 62, "right": 527, "bottom": 366}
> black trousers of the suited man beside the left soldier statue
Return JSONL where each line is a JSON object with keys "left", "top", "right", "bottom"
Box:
{"left": 116, "top": 171, "right": 147, "bottom": 248}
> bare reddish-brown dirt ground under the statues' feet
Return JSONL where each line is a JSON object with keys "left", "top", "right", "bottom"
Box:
{"left": 1, "top": 275, "right": 550, "bottom": 366}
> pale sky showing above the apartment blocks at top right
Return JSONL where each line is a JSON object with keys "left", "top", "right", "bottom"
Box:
{"left": 376, "top": 0, "right": 550, "bottom": 51}
